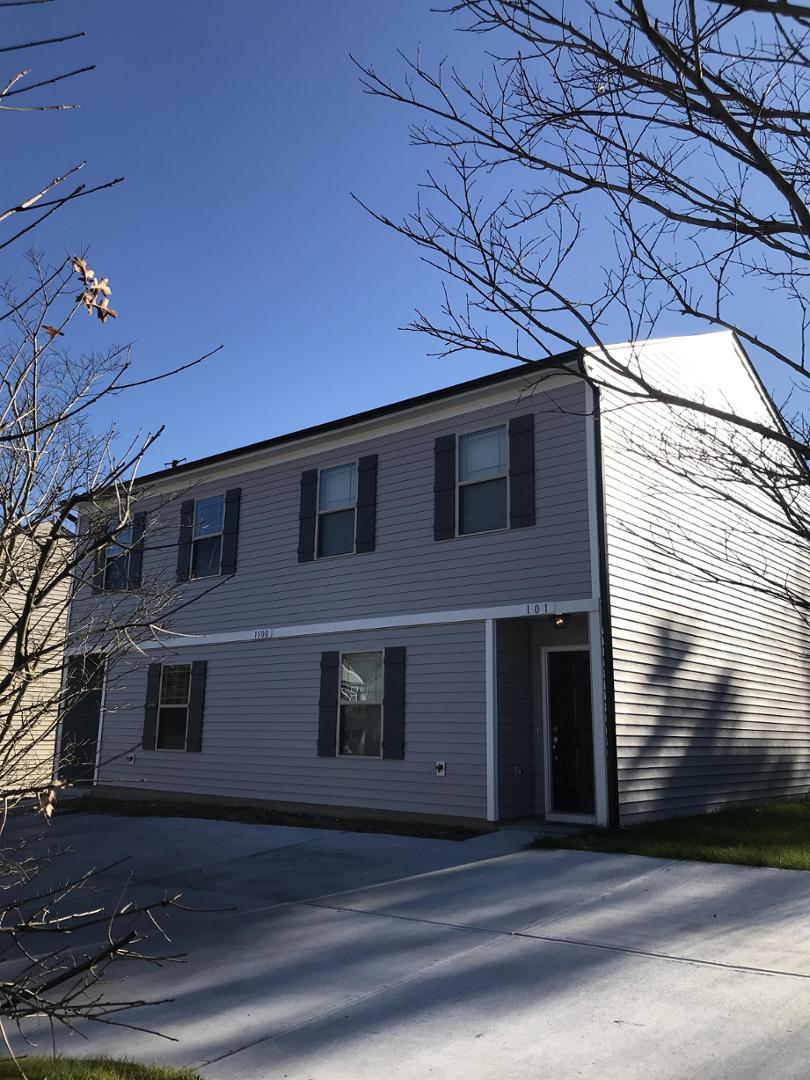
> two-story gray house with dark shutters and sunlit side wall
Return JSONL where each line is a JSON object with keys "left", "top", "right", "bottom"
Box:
{"left": 60, "top": 334, "right": 810, "bottom": 824}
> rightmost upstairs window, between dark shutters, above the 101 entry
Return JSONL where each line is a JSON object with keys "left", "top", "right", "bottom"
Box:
{"left": 458, "top": 427, "right": 509, "bottom": 535}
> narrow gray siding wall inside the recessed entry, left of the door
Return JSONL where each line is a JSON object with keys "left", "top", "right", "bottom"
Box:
{"left": 497, "top": 619, "right": 541, "bottom": 820}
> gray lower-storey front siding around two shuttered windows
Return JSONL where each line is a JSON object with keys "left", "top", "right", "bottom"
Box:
{"left": 98, "top": 622, "right": 486, "bottom": 820}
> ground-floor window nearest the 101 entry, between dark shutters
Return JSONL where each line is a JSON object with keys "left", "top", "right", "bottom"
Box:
{"left": 338, "top": 652, "right": 382, "bottom": 757}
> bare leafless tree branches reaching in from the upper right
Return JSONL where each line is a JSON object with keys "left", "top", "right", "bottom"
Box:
{"left": 359, "top": 0, "right": 810, "bottom": 612}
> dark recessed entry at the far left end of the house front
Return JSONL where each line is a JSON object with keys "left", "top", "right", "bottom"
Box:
{"left": 59, "top": 653, "right": 104, "bottom": 784}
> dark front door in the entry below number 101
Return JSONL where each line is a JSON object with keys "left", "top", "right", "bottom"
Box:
{"left": 546, "top": 649, "right": 594, "bottom": 814}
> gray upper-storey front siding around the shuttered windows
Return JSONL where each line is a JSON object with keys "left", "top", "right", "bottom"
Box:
{"left": 73, "top": 380, "right": 591, "bottom": 633}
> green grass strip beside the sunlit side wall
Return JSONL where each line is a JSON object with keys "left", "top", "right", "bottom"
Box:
{"left": 532, "top": 796, "right": 810, "bottom": 870}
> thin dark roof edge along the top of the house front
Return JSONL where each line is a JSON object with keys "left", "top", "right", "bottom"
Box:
{"left": 136, "top": 349, "right": 584, "bottom": 486}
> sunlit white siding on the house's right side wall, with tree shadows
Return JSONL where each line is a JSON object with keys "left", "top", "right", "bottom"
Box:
{"left": 602, "top": 335, "right": 810, "bottom": 822}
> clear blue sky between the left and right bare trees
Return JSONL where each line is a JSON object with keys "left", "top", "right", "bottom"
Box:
{"left": 2, "top": 0, "right": 794, "bottom": 469}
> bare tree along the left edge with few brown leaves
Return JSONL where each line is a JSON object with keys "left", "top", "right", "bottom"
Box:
{"left": 0, "top": 0, "right": 216, "bottom": 1049}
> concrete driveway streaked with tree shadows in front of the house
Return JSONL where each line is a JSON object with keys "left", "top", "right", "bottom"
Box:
{"left": 9, "top": 814, "right": 810, "bottom": 1080}
